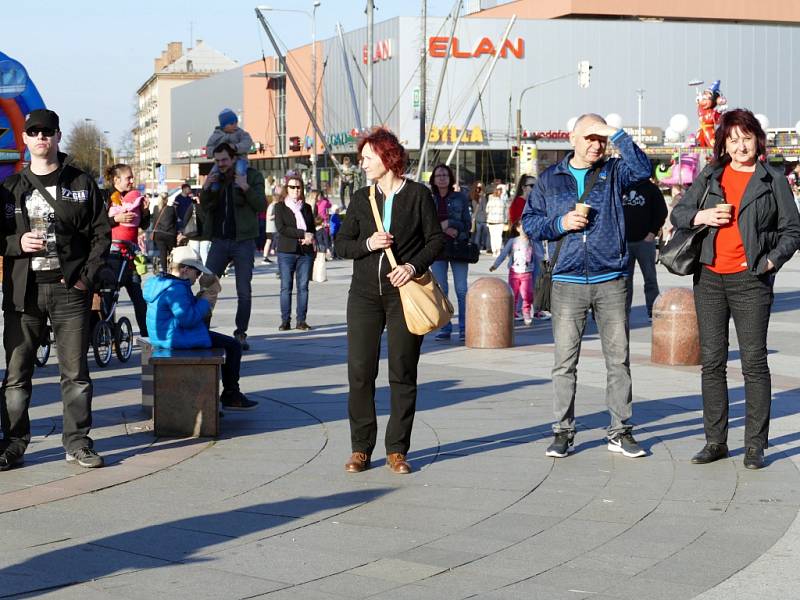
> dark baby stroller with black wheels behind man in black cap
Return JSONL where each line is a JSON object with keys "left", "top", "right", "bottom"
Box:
{"left": 92, "top": 240, "right": 134, "bottom": 367}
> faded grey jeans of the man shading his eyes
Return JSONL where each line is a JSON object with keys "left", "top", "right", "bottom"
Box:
{"left": 550, "top": 278, "right": 632, "bottom": 435}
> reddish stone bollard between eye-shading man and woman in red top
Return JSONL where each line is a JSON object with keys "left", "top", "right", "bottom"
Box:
{"left": 650, "top": 288, "right": 700, "bottom": 365}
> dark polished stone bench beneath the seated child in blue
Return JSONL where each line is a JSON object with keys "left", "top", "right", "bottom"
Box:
{"left": 136, "top": 337, "right": 225, "bottom": 437}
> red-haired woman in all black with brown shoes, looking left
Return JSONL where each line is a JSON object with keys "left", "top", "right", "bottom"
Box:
{"left": 336, "top": 128, "right": 444, "bottom": 474}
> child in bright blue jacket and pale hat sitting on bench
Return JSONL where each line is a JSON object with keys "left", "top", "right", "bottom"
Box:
{"left": 142, "top": 246, "right": 258, "bottom": 410}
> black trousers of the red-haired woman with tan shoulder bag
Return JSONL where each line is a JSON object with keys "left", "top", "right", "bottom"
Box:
{"left": 347, "top": 289, "right": 423, "bottom": 455}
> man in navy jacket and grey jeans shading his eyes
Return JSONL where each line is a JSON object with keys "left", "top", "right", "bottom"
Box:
{"left": 522, "top": 114, "right": 651, "bottom": 458}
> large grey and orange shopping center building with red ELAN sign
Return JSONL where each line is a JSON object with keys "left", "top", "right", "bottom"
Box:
{"left": 162, "top": 0, "right": 800, "bottom": 189}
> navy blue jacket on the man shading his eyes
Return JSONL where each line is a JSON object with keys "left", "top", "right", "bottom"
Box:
{"left": 522, "top": 130, "right": 652, "bottom": 283}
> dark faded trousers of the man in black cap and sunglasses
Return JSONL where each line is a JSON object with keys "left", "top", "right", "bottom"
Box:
{"left": 0, "top": 283, "right": 92, "bottom": 452}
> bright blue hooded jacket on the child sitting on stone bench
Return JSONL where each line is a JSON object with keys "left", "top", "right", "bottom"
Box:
{"left": 142, "top": 275, "right": 211, "bottom": 348}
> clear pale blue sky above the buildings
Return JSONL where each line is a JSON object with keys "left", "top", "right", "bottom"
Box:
{"left": 0, "top": 0, "right": 453, "bottom": 148}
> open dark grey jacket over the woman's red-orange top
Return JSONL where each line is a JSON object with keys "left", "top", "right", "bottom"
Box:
{"left": 670, "top": 161, "right": 800, "bottom": 275}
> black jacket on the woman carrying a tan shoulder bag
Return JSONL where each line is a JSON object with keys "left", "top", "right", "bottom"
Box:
{"left": 336, "top": 179, "right": 444, "bottom": 294}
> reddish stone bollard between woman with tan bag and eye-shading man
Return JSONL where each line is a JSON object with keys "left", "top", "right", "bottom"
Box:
{"left": 465, "top": 277, "right": 514, "bottom": 348}
